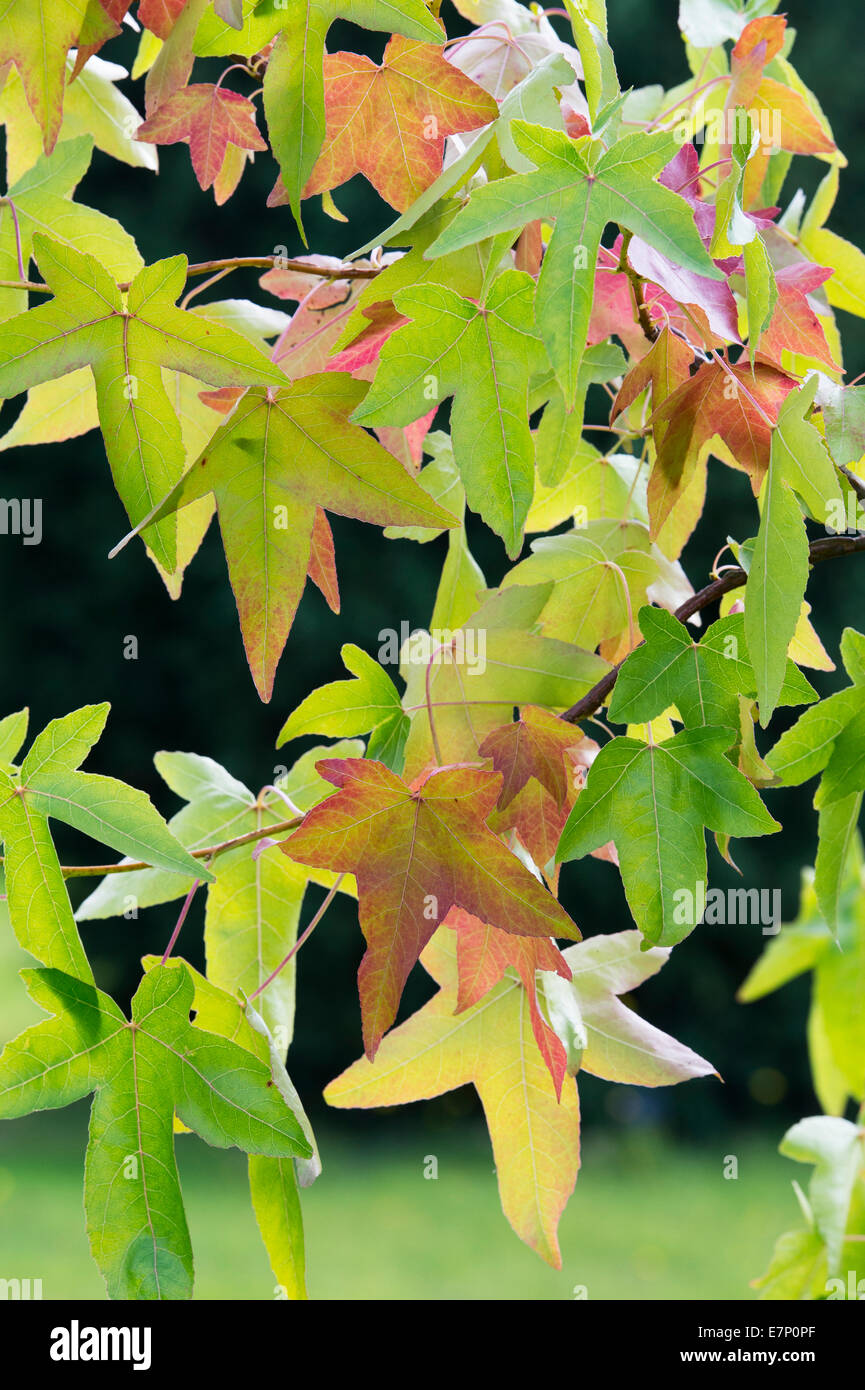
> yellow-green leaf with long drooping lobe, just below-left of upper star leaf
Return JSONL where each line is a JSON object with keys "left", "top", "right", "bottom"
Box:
{"left": 352, "top": 270, "right": 544, "bottom": 556}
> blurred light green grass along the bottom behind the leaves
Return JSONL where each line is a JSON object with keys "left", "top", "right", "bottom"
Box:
{"left": 0, "top": 1106, "right": 798, "bottom": 1301}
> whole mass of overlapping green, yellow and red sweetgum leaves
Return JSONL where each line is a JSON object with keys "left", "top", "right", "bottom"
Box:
{"left": 0, "top": 0, "right": 865, "bottom": 1297}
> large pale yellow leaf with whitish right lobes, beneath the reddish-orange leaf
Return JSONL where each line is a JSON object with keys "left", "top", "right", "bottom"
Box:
{"left": 324, "top": 931, "right": 712, "bottom": 1269}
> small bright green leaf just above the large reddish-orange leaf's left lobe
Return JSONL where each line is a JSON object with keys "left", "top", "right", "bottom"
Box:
{"left": 277, "top": 642, "right": 410, "bottom": 771}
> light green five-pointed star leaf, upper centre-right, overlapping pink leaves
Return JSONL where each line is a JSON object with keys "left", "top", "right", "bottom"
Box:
{"left": 428, "top": 121, "right": 722, "bottom": 404}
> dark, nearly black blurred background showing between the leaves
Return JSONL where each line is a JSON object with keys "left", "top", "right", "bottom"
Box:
{"left": 0, "top": 0, "right": 865, "bottom": 1136}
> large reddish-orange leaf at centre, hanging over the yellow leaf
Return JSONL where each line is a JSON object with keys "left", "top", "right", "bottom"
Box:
{"left": 282, "top": 758, "right": 579, "bottom": 1056}
